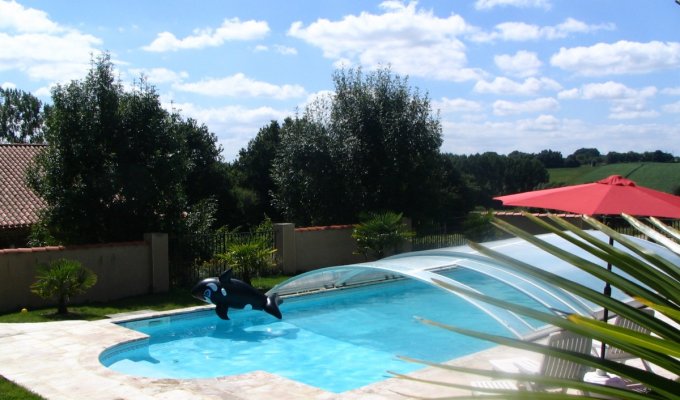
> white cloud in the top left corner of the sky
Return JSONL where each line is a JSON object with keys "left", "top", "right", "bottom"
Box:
{"left": 0, "top": 1, "right": 102, "bottom": 82}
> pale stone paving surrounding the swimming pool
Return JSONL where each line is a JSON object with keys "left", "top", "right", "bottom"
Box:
{"left": 0, "top": 311, "right": 668, "bottom": 400}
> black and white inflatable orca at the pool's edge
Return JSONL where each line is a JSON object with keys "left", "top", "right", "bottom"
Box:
{"left": 191, "top": 269, "right": 282, "bottom": 319}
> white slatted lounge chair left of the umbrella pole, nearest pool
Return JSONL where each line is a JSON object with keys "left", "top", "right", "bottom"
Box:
{"left": 470, "top": 331, "right": 592, "bottom": 394}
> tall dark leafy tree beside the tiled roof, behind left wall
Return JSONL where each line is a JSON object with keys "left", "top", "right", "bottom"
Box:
{"left": 29, "top": 54, "right": 216, "bottom": 243}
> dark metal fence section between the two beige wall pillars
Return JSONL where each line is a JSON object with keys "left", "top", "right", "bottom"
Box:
{"left": 168, "top": 230, "right": 276, "bottom": 287}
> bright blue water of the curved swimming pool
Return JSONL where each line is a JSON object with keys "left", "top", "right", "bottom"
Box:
{"left": 100, "top": 269, "right": 548, "bottom": 393}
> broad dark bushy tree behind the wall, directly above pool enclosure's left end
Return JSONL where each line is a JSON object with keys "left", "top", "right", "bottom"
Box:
{"left": 273, "top": 69, "right": 452, "bottom": 227}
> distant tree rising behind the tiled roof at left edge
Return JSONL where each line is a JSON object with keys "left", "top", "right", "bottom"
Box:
{"left": 0, "top": 87, "right": 49, "bottom": 143}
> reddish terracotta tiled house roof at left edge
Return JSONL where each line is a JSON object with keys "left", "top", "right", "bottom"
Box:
{"left": 0, "top": 144, "right": 45, "bottom": 229}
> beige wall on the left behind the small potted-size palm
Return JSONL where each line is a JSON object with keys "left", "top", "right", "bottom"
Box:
{"left": 0, "top": 233, "right": 169, "bottom": 312}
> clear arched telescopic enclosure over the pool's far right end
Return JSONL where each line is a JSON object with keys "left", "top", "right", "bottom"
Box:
{"left": 267, "top": 231, "right": 680, "bottom": 338}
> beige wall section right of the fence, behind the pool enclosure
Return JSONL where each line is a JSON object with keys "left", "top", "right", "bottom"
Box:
{"left": 275, "top": 224, "right": 365, "bottom": 274}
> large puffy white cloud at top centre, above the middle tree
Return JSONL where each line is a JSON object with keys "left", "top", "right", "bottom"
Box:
{"left": 288, "top": 1, "right": 484, "bottom": 82}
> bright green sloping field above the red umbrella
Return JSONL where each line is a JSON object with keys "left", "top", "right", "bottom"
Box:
{"left": 548, "top": 163, "right": 680, "bottom": 193}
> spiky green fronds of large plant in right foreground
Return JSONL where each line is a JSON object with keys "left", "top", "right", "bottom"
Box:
{"left": 395, "top": 213, "right": 680, "bottom": 400}
